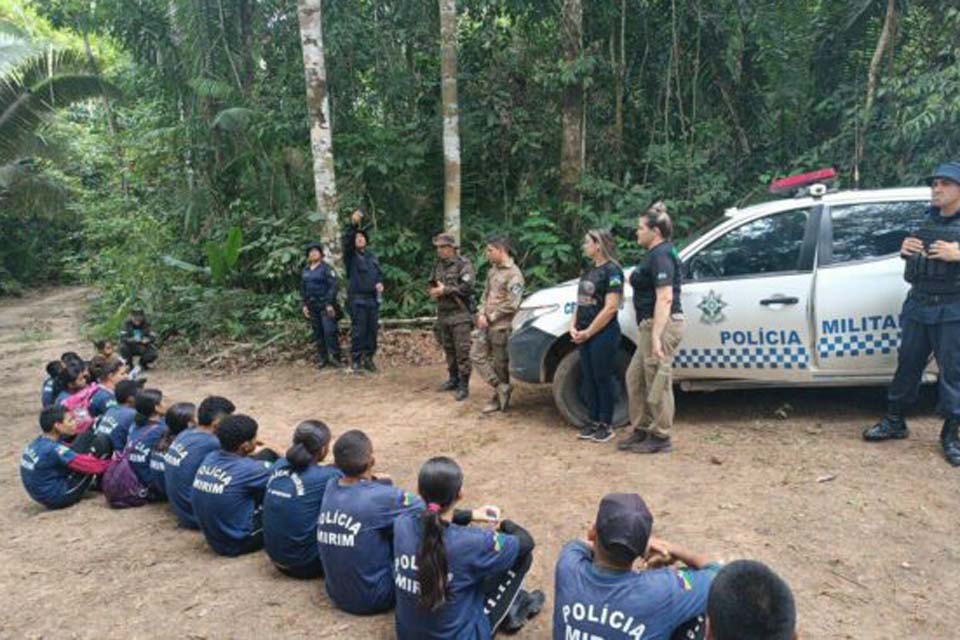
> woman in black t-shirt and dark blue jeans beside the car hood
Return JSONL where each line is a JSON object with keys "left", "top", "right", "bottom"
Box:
{"left": 570, "top": 229, "right": 623, "bottom": 442}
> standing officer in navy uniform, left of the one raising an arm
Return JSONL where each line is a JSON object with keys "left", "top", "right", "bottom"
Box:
{"left": 300, "top": 242, "right": 343, "bottom": 369}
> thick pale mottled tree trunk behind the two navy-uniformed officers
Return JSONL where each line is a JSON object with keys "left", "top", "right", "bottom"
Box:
{"left": 297, "top": 0, "right": 342, "bottom": 269}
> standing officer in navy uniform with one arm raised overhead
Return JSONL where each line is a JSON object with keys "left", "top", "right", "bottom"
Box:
{"left": 343, "top": 209, "right": 383, "bottom": 372}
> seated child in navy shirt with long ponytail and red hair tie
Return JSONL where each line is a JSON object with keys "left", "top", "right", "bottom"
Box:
{"left": 393, "top": 457, "right": 543, "bottom": 640}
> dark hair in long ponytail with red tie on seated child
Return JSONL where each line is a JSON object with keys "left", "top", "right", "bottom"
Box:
{"left": 417, "top": 456, "right": 463, "bottom": 611}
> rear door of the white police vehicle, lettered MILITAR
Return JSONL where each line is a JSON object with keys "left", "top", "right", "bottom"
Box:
{"left": 814, "top": 200, "right": 929, "bottom": 377}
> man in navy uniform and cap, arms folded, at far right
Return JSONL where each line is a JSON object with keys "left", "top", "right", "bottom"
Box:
{"left": 863, "top": 162, "right": 960, "bottom": 467}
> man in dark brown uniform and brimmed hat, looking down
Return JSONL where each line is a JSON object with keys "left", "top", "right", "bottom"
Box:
{"left": 427, "top": 233, "right": 477, "bottom": 400}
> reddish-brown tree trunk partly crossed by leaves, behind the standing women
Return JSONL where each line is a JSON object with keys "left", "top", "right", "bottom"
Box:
{"left": 560, "top": 0, "right": 584, "bottom": 207}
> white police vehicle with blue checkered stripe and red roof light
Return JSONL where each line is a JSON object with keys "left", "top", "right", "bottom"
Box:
{"left": 509, "top": 170, "right": 936, "bottom": 426}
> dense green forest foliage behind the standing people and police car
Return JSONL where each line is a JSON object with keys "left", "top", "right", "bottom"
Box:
{"left": 0, "top": 0, "right": 960, "bottom": 338}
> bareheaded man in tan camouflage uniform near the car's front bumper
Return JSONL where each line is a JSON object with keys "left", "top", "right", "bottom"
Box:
{"left": 470, "top": 237, "right": 523, "bottom": 413}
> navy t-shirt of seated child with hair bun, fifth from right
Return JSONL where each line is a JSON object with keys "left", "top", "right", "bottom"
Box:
{"left": 263, "top": 458, "right": 343, "bottom": 568}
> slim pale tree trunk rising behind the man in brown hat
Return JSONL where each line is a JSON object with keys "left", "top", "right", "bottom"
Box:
{"left": 439, "top": 0, "right": 460, "bottom": 244}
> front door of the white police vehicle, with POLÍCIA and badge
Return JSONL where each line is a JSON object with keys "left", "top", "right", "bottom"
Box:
{"left": 674, "top": 206, "right": 822, "bottom": 382}
